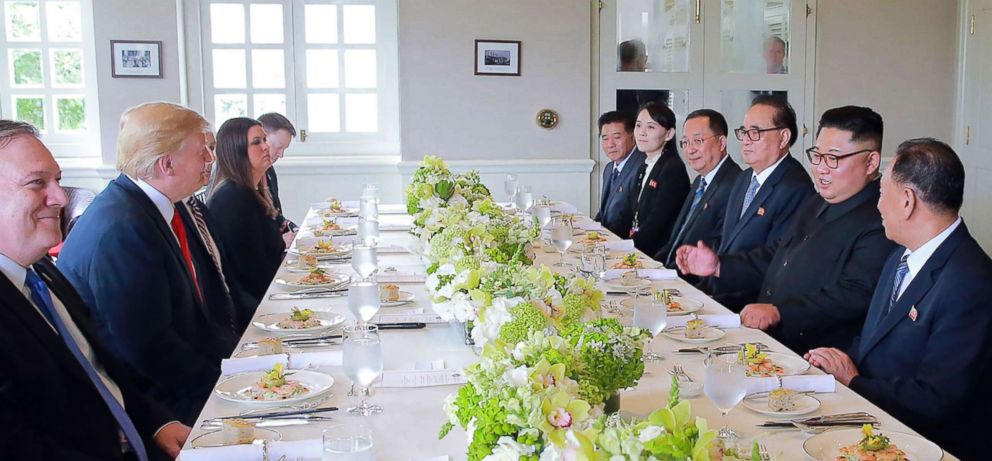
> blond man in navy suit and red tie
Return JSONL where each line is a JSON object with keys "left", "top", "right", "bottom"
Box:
{"left": 59, "top": 103, "right": 237, "bottom": 422}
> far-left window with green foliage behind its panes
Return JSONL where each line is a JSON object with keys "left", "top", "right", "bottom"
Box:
{"left": 0, "top": 0, "right": 100, "bottom": 157}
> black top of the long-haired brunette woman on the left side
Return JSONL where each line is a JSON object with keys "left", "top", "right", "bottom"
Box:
{"left": 207, "top": 181, "right": 286, "bottom": 310}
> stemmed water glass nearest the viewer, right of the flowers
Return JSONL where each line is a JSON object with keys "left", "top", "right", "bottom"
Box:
{"left": 703, "top": 353, "right": 747, "bottom": 446}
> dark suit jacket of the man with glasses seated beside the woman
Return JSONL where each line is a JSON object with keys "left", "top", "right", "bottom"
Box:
{"left": 654, "top": 157, "right": 741, "bottom": 266}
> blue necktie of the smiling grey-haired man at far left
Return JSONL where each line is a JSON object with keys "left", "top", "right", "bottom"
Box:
{"left": 24, "top": 269, "right": 148, "bottom": 461}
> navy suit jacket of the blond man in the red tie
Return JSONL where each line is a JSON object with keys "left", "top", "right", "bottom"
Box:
{"left": 58, "top": 175, "right": 238, "bottom": 424}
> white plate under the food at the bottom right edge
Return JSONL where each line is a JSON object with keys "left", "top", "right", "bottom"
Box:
{"left": 803, "top": 428, "right": 944, "bottom": 461}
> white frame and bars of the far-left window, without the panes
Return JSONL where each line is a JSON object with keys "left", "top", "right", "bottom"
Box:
{"left": 0, "top": 0, "right": 100, "bottom": 160}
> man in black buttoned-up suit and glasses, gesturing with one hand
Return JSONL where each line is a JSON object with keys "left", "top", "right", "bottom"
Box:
{"left": 677, "top": 106, "right": 894, "bottom": 353}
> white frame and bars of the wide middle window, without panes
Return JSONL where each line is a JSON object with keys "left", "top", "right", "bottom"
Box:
{"left": 183, "top": 0, "right": 400, "bottom": 159}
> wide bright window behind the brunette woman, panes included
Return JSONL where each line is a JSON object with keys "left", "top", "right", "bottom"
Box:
{"left": 199, "top": 0, "right": 399, "bottom": 155}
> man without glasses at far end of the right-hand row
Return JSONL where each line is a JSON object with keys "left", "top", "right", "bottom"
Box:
{"left": 595, "top": 111, "right": 644, "bottom": 238}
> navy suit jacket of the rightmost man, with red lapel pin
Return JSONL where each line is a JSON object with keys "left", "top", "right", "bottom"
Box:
{"left": 848, "top": 222, "right": 992, "bottom": 460}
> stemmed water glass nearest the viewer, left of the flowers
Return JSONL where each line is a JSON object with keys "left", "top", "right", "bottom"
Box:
{"left": 342, "top": 324, "right": 382, "bottom": 416}
